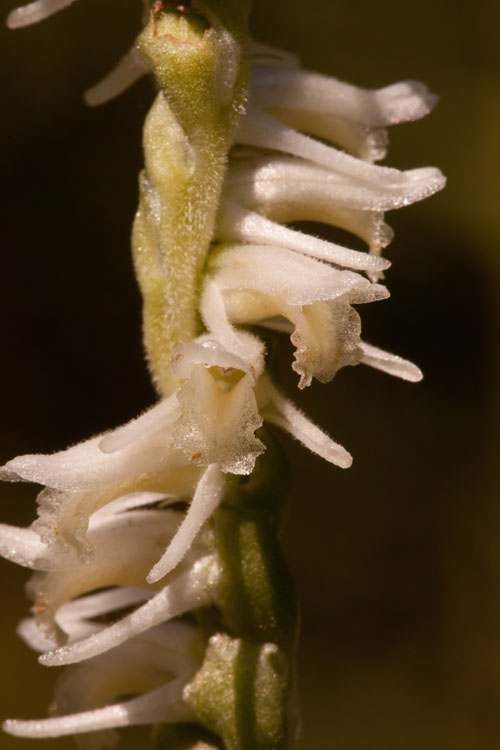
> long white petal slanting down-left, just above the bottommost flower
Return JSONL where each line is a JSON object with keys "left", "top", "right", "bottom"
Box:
{"left": 40, "top": 556, "right": 220, "bottom": 667}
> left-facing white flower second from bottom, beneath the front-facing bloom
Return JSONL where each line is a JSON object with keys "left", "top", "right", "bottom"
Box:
{"left": 0, "top": 494, "right": 221, "bottom": 663}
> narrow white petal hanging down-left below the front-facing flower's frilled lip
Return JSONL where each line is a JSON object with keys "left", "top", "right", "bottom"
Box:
{"left": 147, "top": 464, "right": 225, "bottom": 583}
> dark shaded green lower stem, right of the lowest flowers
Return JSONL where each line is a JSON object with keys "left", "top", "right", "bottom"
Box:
{"left": 185, "top": 428, "right": 297, "bottom": 750}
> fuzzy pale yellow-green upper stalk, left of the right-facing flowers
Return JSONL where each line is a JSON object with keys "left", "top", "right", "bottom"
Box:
{"left": 132, "top": 0, "right": 248, "bottom": 395}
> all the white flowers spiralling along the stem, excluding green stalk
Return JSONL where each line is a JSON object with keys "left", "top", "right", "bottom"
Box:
{"left": 0, "top": 0, "right": 444, "bottom": 750}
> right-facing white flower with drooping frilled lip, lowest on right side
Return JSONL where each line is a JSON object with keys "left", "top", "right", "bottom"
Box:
{"left": 205, "top": 245, "right": 389, "bottom": 388}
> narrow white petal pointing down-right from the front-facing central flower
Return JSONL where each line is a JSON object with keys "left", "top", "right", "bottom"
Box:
{"left": 261, "top": 379, "right": 352, "bottom": 469}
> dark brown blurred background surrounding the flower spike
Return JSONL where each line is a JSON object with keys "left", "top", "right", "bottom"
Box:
{"left": 0, "top": 0, "right": 500, "bottom": 750}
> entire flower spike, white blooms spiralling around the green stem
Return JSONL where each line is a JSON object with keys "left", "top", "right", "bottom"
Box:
{"left": 0, "top": 0, "right": 444, "bottom": 750}
